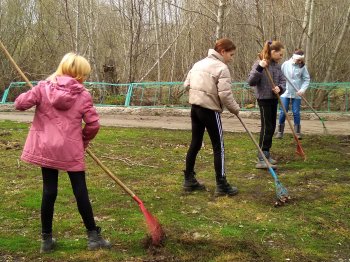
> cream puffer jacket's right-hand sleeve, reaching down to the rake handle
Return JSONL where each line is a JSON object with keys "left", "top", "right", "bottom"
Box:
{"left": 218, "top": 68, "right": 240, "bottom": 115}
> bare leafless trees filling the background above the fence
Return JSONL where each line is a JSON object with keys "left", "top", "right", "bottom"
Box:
{"left": 0, "top": 0, "right": 350, "bottom": 96}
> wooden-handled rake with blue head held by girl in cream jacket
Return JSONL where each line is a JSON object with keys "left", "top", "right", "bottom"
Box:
{"left": 237, "top": 115, "right": 291, "bottom": 207}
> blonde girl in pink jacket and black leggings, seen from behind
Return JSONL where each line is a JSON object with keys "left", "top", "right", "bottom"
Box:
{"left": 15, "top": 53, "right": 110, "bottom": 253}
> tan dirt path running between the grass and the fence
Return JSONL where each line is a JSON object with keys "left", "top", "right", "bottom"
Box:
{"left": 0, "top": 110, "right": 350, "bottom": 135}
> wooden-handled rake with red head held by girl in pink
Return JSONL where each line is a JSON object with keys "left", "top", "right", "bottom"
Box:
{"left": 0, "top": 40, "right": 165, "bottom": 246}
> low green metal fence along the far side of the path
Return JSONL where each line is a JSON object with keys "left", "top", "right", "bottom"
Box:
{"left": 1, "top": 82, "right": 350, "bottom": 112}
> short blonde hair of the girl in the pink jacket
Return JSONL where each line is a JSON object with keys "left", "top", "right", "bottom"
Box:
{"left": 53, "top": 53, "right": 91, "bottom": 83}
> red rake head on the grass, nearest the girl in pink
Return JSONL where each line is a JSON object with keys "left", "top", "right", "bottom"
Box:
{"left": 134, "top": 196, "right": 165, "bottom": 246}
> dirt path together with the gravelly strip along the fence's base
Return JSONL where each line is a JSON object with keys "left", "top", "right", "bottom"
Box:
{"left": 0, "top": 105, "right": 350, "bottom": 135}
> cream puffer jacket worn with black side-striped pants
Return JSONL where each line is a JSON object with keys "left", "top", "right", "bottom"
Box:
{"left": 184, "top": 49, "right": 240, "bottom": 115}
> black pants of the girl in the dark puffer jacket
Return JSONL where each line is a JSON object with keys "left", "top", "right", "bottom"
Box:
{"left": 258, "top": 99, "right": 278, "bottom": 151}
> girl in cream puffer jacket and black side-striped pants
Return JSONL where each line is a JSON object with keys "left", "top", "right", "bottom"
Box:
{"left": 183, "top": 39, "right": 240, "bottom": 196}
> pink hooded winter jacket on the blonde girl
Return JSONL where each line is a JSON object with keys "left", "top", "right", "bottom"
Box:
{"left": 15, "top": 76, "right": 100, "bottom": 171}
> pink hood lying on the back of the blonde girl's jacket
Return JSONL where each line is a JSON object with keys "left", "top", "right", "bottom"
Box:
{"left": 46, "top": 76, "right": 85, "bottom": 111}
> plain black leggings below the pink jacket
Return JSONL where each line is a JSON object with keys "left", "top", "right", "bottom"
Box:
{"left": 41, "top": 167, "right": 96, "bottom": 233}
